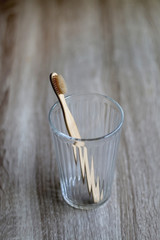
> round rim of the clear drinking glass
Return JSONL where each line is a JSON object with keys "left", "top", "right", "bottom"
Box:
{"left": 48, "top": 93, "right": 124, "bottom": 142}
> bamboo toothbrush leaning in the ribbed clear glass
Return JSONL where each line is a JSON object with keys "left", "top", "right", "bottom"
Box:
{"left": 50, "top": 73, "right": 103, "bottom": 202}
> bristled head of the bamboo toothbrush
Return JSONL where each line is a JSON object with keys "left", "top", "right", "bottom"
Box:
{"left": 50, "top": 73, "right": 67, "bottom": 94}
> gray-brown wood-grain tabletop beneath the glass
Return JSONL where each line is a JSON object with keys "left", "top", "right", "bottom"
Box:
{"left": 0, "top": 0, "right": 160, "bottom": 240}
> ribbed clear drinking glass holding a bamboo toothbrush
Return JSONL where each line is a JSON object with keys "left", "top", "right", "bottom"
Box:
{"left": 49, "top": 93, "right": 124, "bottom": 209}
